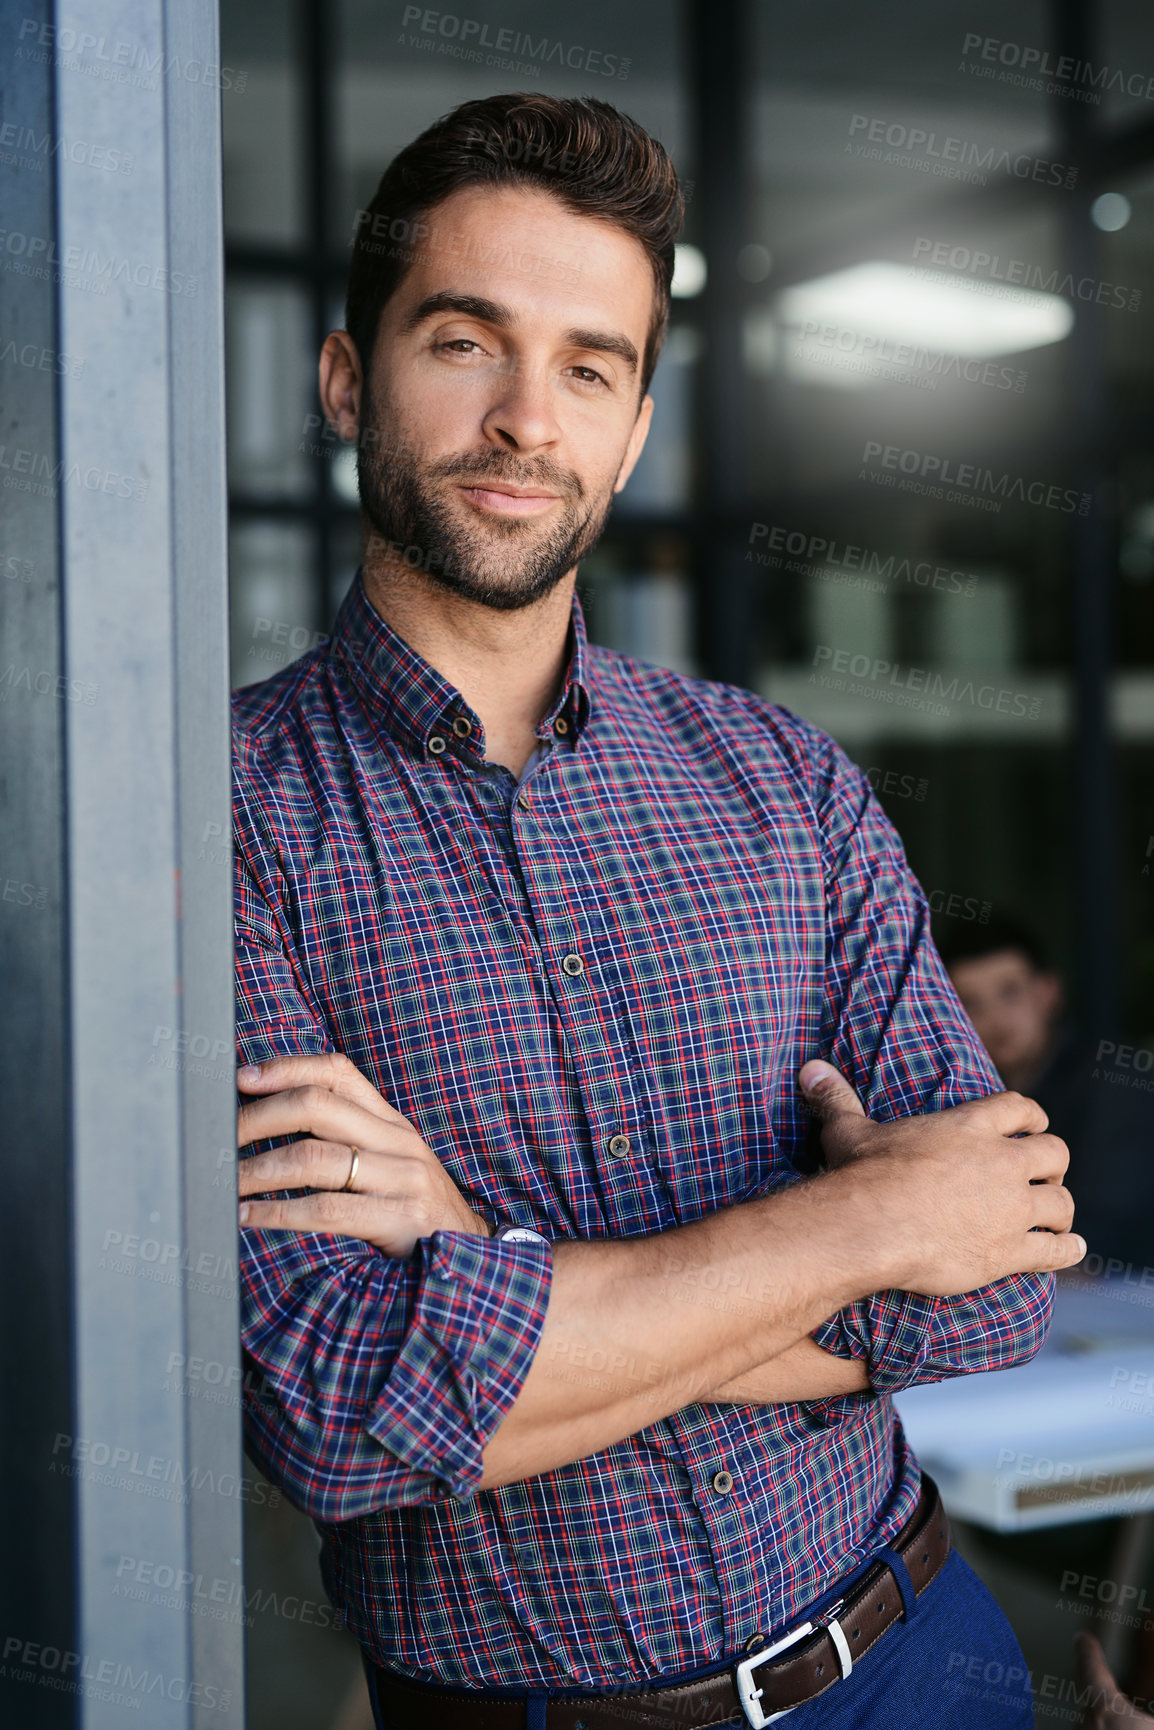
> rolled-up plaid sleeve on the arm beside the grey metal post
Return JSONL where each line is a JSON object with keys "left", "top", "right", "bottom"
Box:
{"left": 235, "top": 823, "right": 552, "bottom": 1521}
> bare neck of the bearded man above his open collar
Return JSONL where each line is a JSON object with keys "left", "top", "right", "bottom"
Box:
{"left": 363, "top": 561, "right": 576, "bottom": 777}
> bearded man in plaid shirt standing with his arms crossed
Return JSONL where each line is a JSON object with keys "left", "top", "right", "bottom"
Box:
{"left": 235, "top": 93, "right": 1085, "bottom": 1730}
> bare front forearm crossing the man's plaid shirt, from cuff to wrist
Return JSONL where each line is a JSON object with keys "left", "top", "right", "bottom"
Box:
{"left": 479, "top": 1173, "right": 879, "bottom": 1490}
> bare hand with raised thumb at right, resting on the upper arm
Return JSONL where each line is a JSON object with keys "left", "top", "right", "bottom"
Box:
{"left": 798, "top": 1062, "right": 1087, "bottom": 1298}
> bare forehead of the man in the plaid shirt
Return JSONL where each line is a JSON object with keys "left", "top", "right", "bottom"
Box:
{"left": 393, "top": 187, "right": 656, "bottom": 333}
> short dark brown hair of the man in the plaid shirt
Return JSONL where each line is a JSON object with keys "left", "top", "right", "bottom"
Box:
{"left": 344, "top": 90, "right": 685, "bottom": 401}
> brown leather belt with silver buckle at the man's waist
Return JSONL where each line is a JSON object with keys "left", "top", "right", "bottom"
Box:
{"left": 370, "top": 1474, "right": 950, "bottom": 1730}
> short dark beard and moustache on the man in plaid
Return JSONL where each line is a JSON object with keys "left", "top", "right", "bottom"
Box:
{"left": 356, "top": 389, "right": 612, "bottom": 612}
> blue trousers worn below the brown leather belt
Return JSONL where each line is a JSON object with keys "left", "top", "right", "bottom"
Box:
{"left": 369, "top": 1550, "right": 1035, "bottom": 1730}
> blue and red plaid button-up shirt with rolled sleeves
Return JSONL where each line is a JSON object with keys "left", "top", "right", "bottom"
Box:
{"left": 234, "top": 573, "right": 1052, "bottom": 1688}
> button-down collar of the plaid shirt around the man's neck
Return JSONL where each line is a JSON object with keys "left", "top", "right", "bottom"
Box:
{"left": 329, "top": 566, "right": 590, "bottom": 759}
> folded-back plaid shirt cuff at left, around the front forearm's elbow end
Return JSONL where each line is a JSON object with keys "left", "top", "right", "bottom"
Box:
{"left": 365, "top": 1232, "right": 554, "bottom": 1496}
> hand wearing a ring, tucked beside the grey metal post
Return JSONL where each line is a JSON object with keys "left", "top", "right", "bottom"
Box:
{"left": 237, "top": 1052, "right": 490, "bottom": 1256}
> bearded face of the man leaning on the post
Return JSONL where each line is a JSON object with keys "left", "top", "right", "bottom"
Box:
{"left": 356, "top": 187, "right": 654, "bottom": 611}
